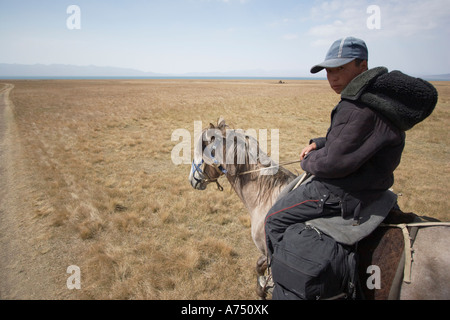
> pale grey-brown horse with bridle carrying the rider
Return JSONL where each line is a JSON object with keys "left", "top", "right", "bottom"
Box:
{"left": 189, "top": 117, "right": 450, "bottom": 300}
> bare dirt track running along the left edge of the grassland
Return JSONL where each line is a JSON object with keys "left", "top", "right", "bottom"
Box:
{"left": 0, "top": 84, "right": 77, "bottom": 300}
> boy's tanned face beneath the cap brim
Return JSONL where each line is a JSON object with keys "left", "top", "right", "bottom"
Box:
{"left": 326, "top": 61, "right": 367, "bottom": 94}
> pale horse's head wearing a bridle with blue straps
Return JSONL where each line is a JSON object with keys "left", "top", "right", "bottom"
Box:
{"left": 189, "top": 118, "right": 228, "bottom": 191}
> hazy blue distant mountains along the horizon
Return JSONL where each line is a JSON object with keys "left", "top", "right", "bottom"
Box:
{"left": 0, "top": 63, "right": 450, "bottom": 81}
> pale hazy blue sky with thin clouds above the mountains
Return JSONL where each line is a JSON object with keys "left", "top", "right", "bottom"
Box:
{"left": 0, "top": 0, "right": 450, "bottom": 76}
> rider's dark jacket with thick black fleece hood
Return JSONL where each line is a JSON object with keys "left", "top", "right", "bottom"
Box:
{"left": 301, "top": 67, "right": 437, "bottom": 198}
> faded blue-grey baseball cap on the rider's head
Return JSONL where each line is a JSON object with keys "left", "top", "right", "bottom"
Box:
{"left": 311, "top": 37, "right": 369, "bottom": 73}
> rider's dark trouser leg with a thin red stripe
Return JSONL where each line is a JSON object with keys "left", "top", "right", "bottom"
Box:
{"left": 265, "top": 180, "right": 340, "bottom": 259}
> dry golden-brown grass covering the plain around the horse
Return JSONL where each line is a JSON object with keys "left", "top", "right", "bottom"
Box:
{"left": 4, "top": 80, "right": 450, "bottom": 299}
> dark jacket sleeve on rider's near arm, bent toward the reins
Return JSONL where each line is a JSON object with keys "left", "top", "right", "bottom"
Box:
{"left": 301, "top": 107, "right": 389, "bottom": 179}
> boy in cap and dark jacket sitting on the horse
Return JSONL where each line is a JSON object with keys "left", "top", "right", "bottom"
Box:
{"left": 265, "top": 37, "right": 437, "bottom": 299}
